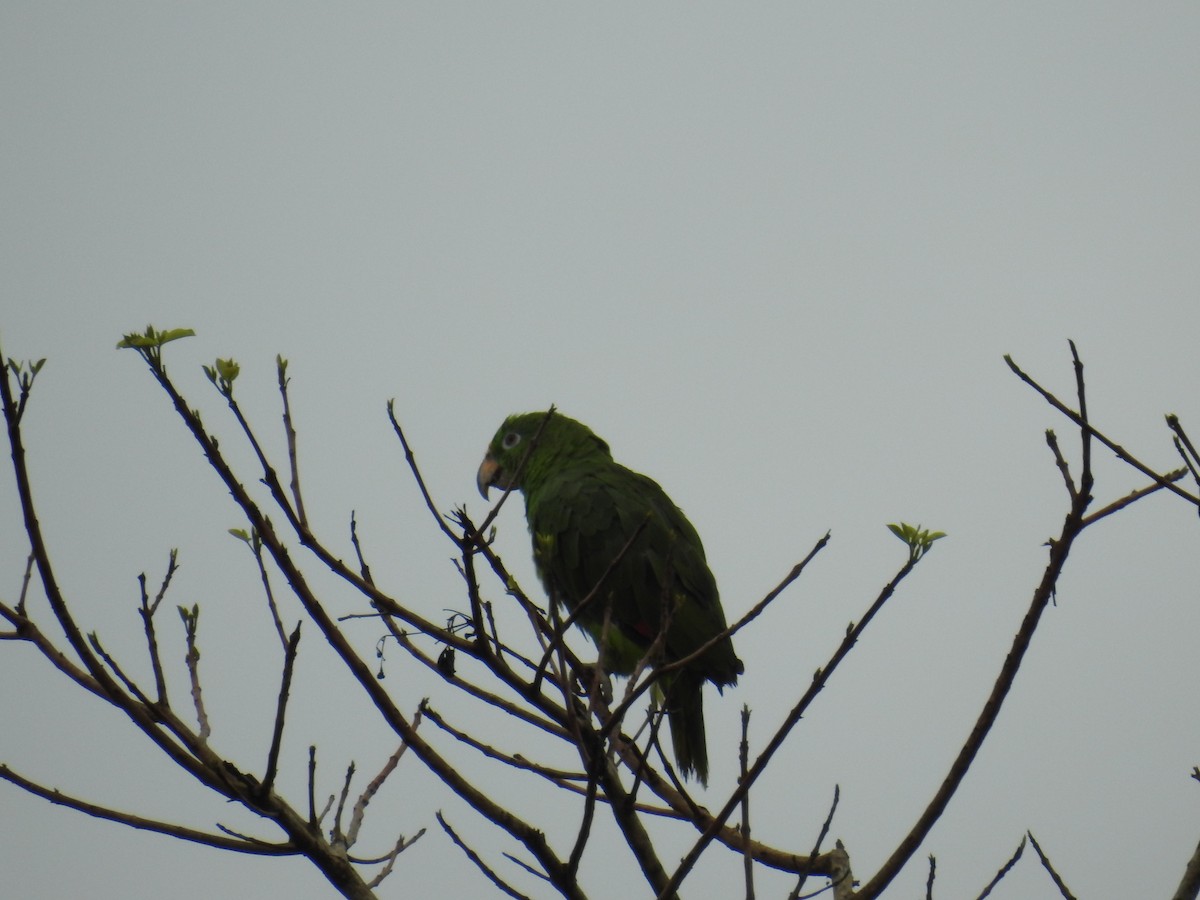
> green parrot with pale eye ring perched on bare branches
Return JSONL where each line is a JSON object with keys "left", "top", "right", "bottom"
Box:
{"left": 476, "top": 412, "right": 743, "bottom": 785}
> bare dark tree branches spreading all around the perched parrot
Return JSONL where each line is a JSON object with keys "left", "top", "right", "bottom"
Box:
{"left": 7, "top": 330, "right": 1200, "bottom": 900}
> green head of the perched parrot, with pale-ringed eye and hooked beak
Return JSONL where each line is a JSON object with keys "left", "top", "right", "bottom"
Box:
{"left": 475, "top": 408, "right": 612, "bottom": 499}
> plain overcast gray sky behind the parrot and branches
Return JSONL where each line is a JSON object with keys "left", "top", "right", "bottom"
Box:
{"left": 0, "top": 0, "right": 1200, "bottom": 900}
